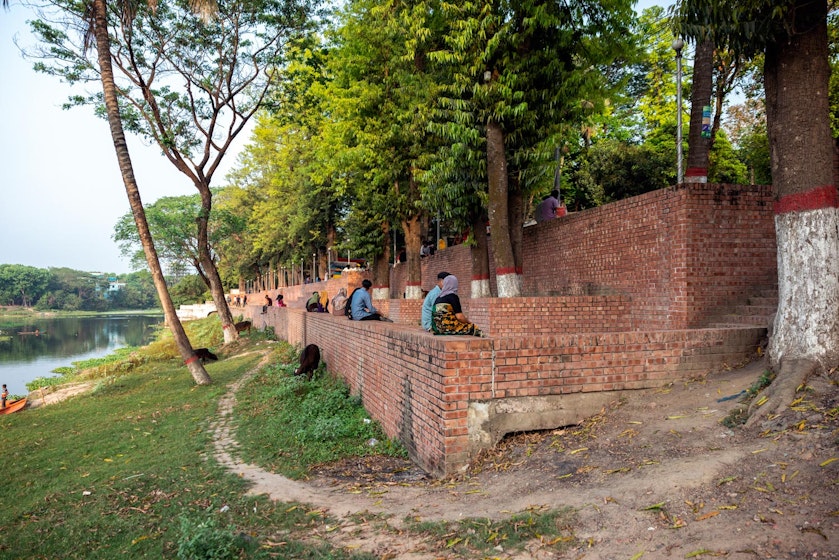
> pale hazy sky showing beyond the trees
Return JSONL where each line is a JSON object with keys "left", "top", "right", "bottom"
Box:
{"left": 0, "top": 0, "right": 669, "bottom": 274}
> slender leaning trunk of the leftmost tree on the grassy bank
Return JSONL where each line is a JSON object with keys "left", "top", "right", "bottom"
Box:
{"left": 93, "top": 0, "right": 212, "bottom": 385}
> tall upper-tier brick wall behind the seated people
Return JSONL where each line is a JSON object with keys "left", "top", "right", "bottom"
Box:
{"left": 398, "top": 183, "right": 777, "bottom": 329}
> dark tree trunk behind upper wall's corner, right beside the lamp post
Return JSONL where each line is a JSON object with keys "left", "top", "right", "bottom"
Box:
{"left": 685, "top": 38, "right": 714, "bottom": 183}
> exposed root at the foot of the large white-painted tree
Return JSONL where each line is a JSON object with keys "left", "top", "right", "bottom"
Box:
{"left": 746, "top": 359, "right": 819, "bottom": 429}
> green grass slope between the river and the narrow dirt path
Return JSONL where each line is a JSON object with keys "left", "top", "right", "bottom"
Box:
{"left": 0, "top": 318, "right": 374, "bottom": 559}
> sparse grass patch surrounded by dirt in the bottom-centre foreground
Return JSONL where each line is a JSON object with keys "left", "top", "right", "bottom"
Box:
{"left": 406, "top": 508, "right": 579, "bottom": 558}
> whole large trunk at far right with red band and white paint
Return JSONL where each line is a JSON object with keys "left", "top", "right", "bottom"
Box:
{"left": 749, "top": 0, "right": 839, "bottom": 423}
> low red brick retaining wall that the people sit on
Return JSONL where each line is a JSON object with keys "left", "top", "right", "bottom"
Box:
{"left": 247, "top": 306, "right": 766, "bottom": 475}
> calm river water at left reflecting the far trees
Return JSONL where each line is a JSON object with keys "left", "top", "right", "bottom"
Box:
{"left": 0, "top": 314, "right": 163, "bottom": 395}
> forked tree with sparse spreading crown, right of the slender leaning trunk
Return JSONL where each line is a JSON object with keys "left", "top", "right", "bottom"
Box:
{"left": 30, "top": 0, "right": 313, "bottom": 342}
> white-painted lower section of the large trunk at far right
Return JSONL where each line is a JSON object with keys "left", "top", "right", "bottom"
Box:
{"left": 769, "top": 208, "right": 839, "bottom": 368}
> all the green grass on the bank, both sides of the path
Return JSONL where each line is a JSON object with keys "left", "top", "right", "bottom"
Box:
{"left": 0, "top": 318, "right": 574, "bottom": 560}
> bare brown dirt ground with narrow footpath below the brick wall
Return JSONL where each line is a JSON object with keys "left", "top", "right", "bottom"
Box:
{"left": 216, "top": 361, "right": 839, "bottom": 559}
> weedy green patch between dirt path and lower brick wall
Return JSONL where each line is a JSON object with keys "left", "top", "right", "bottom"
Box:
{"left": 234, "top": 352, "right": 407, "bottom": 479}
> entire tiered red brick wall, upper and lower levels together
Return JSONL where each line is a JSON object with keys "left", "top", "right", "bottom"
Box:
{"left": 244, "top": 184, "right": 777, "bottom": 475}
